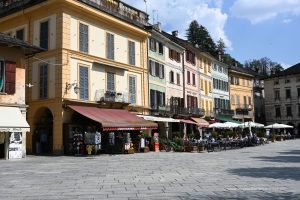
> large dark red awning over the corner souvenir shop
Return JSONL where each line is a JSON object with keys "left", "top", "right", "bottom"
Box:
{"left": 69, "top": 106, "right": 157, "bottom": 131}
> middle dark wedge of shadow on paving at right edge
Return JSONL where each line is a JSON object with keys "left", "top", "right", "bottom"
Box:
{"left": 228, "top": 167, "right": 300, "bottom": 181}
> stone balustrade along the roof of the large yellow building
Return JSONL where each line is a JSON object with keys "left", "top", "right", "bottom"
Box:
{"left": 78, "top": 0, "right": 148, "bottom": 26}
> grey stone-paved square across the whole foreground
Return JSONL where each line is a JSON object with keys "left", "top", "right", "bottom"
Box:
{"left": 0, "top": 140, "right": 300, "bottom": 200}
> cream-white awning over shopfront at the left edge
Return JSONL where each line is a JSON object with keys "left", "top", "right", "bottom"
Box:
{"left": 0, "top": 107, "right": 29, "bottom": 132}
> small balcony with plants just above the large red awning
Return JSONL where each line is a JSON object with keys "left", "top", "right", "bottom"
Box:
{"left": 95, "top": 90, "right": 130, "bottom": 103}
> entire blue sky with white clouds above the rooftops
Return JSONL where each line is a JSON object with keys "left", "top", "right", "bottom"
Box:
{"left": 124, "top": 0, "right": 300, "bottom": 67}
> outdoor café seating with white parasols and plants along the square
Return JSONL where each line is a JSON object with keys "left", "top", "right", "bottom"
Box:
{"left": 160, "top": 122, "right": 295, "bottom": 153}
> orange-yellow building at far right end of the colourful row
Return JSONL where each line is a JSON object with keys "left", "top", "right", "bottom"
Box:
{"left": 229, "top": 67, "right": 255, "bottom": 121}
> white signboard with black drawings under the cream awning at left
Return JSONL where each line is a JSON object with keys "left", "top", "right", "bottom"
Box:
{"left": 8, "top": 132, "right": 22, "bottom": 159}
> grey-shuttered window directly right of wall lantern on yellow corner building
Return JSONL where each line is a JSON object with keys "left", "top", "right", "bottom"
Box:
{"left": 79, "top": 66, "right": 89, "bottom": 100}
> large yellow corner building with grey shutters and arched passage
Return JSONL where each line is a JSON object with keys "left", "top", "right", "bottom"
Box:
{"left": 0, "top": 0, "right": 149, "bottom": 154}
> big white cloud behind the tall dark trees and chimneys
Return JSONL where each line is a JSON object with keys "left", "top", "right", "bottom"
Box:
{"left": 124, "top": 0, "right": 232, "bottom": 50}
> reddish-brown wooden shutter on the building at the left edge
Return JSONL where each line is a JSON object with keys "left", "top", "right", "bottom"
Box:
{"left": 5, "top": 61, "right": 16, "bottom": 94}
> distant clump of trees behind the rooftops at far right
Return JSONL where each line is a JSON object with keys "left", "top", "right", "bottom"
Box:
{"left": 244, "top": 57, "right": 284, "bottom": 75}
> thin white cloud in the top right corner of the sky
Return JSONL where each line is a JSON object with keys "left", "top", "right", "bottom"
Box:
{"left": 230, "top": 0, "right": 300, "bottom": 24}
